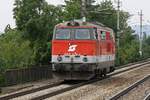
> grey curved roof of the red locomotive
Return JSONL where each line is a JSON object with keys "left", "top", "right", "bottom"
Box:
{"left": 56, "top": 20, "right": 113, "bottom": 31}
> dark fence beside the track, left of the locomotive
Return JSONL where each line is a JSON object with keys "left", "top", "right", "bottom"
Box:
{"left": 4, "top": 65, "right": 52, "bottom": 86}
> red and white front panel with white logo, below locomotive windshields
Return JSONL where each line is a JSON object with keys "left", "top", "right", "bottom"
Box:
{"left": 52, "top": 40, "right": 96, "bottom": 63}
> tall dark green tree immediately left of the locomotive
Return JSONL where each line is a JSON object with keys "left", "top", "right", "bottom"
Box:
{"left": 14, "top": 0, "right": 62, "bottom": 63}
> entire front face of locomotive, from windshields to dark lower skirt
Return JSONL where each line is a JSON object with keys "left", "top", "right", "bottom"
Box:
{"left": 52, "top": 23, "right": 97, "bottom": 79}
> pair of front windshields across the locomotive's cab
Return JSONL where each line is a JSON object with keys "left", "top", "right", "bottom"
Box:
{"left": 54, "top": 28, "right": 95, "bottom": 40}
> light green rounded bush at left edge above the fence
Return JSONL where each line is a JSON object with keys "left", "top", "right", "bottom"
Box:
{"left": 0, "top": 30, "right": 34, "bottom": 71}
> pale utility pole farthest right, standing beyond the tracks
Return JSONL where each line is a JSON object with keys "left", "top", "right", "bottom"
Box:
{"left": 139, "top": 10, "right": 143, "bottom": 56}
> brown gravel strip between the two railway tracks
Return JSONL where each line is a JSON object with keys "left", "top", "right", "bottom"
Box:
{"left": 47, "top": 66, "right": 150, "bottom": 100}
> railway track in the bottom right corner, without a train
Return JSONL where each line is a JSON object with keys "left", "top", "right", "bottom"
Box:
{"left": 109, "top": 75, "right": 150, "bottom": 100}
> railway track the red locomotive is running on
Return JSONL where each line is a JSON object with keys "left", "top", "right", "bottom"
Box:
{"left": 0, "top": 61, "right": 150, "bottom": 100}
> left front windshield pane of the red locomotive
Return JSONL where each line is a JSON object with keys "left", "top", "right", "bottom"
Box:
{"left": 55, "top": 29, "right": 71, "bottom": 39}
